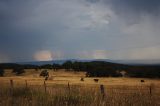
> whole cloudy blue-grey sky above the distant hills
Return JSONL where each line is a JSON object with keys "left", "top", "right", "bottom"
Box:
{"left": 0, "top": 0, "right": 160, "bottom": 63}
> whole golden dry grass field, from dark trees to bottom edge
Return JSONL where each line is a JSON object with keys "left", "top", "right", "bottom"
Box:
{"left": 0, "top": 69, "right": 160, "bottom": 106}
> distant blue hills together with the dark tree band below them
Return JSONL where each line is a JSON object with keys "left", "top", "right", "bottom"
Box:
{"left": 0, "top": 59, "right": 160, "bottom": 78}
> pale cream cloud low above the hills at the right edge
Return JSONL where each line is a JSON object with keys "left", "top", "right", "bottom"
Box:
{"left": 109, "top": 46, "right": 160, "bottom": 60}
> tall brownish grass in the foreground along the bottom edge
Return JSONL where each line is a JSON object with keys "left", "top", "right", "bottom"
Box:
{"left": 0, "top": 85, "right": 159, "bottom": 106}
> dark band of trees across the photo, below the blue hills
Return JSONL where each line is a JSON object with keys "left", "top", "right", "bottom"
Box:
{"left": 0, "top": 61, "right": 160, "bottom": 78}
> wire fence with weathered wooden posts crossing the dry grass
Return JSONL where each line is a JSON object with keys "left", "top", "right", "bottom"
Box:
{"left": 4, "top": 80, "right": 160, "bottom": 98}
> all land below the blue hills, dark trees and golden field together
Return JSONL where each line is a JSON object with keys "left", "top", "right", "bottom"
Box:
{"left": 0, "top": 61, "right": 160, "bottom": 106}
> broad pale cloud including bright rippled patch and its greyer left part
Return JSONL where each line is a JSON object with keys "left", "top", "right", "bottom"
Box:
{"left": 23, "top": 0, "right": 113, "bottom": 29}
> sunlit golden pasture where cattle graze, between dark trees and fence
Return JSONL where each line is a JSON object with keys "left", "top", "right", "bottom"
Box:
{"left": 0, "top": 69, "right": 160, "bottom": 85}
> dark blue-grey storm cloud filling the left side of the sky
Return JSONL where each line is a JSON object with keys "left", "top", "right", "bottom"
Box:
{"left": 0, "top": 0, "right": 53, "bottom": 61}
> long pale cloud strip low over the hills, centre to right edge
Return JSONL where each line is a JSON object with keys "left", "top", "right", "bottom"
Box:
{"left": 77, "top": 45, "right": 160, "bottom": 60}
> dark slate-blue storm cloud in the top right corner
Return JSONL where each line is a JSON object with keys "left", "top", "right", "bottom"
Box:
{"left": 105, "top": 0, "right": 160, "bottom": 19}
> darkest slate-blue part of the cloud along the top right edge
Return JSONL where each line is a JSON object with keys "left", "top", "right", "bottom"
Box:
{"left": 104, "top": 0, "right": 160, "bottom": 15}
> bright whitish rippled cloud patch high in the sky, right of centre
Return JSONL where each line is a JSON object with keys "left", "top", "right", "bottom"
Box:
{"left": 69, "top": 0, "right": 113, "bottom": 30}
